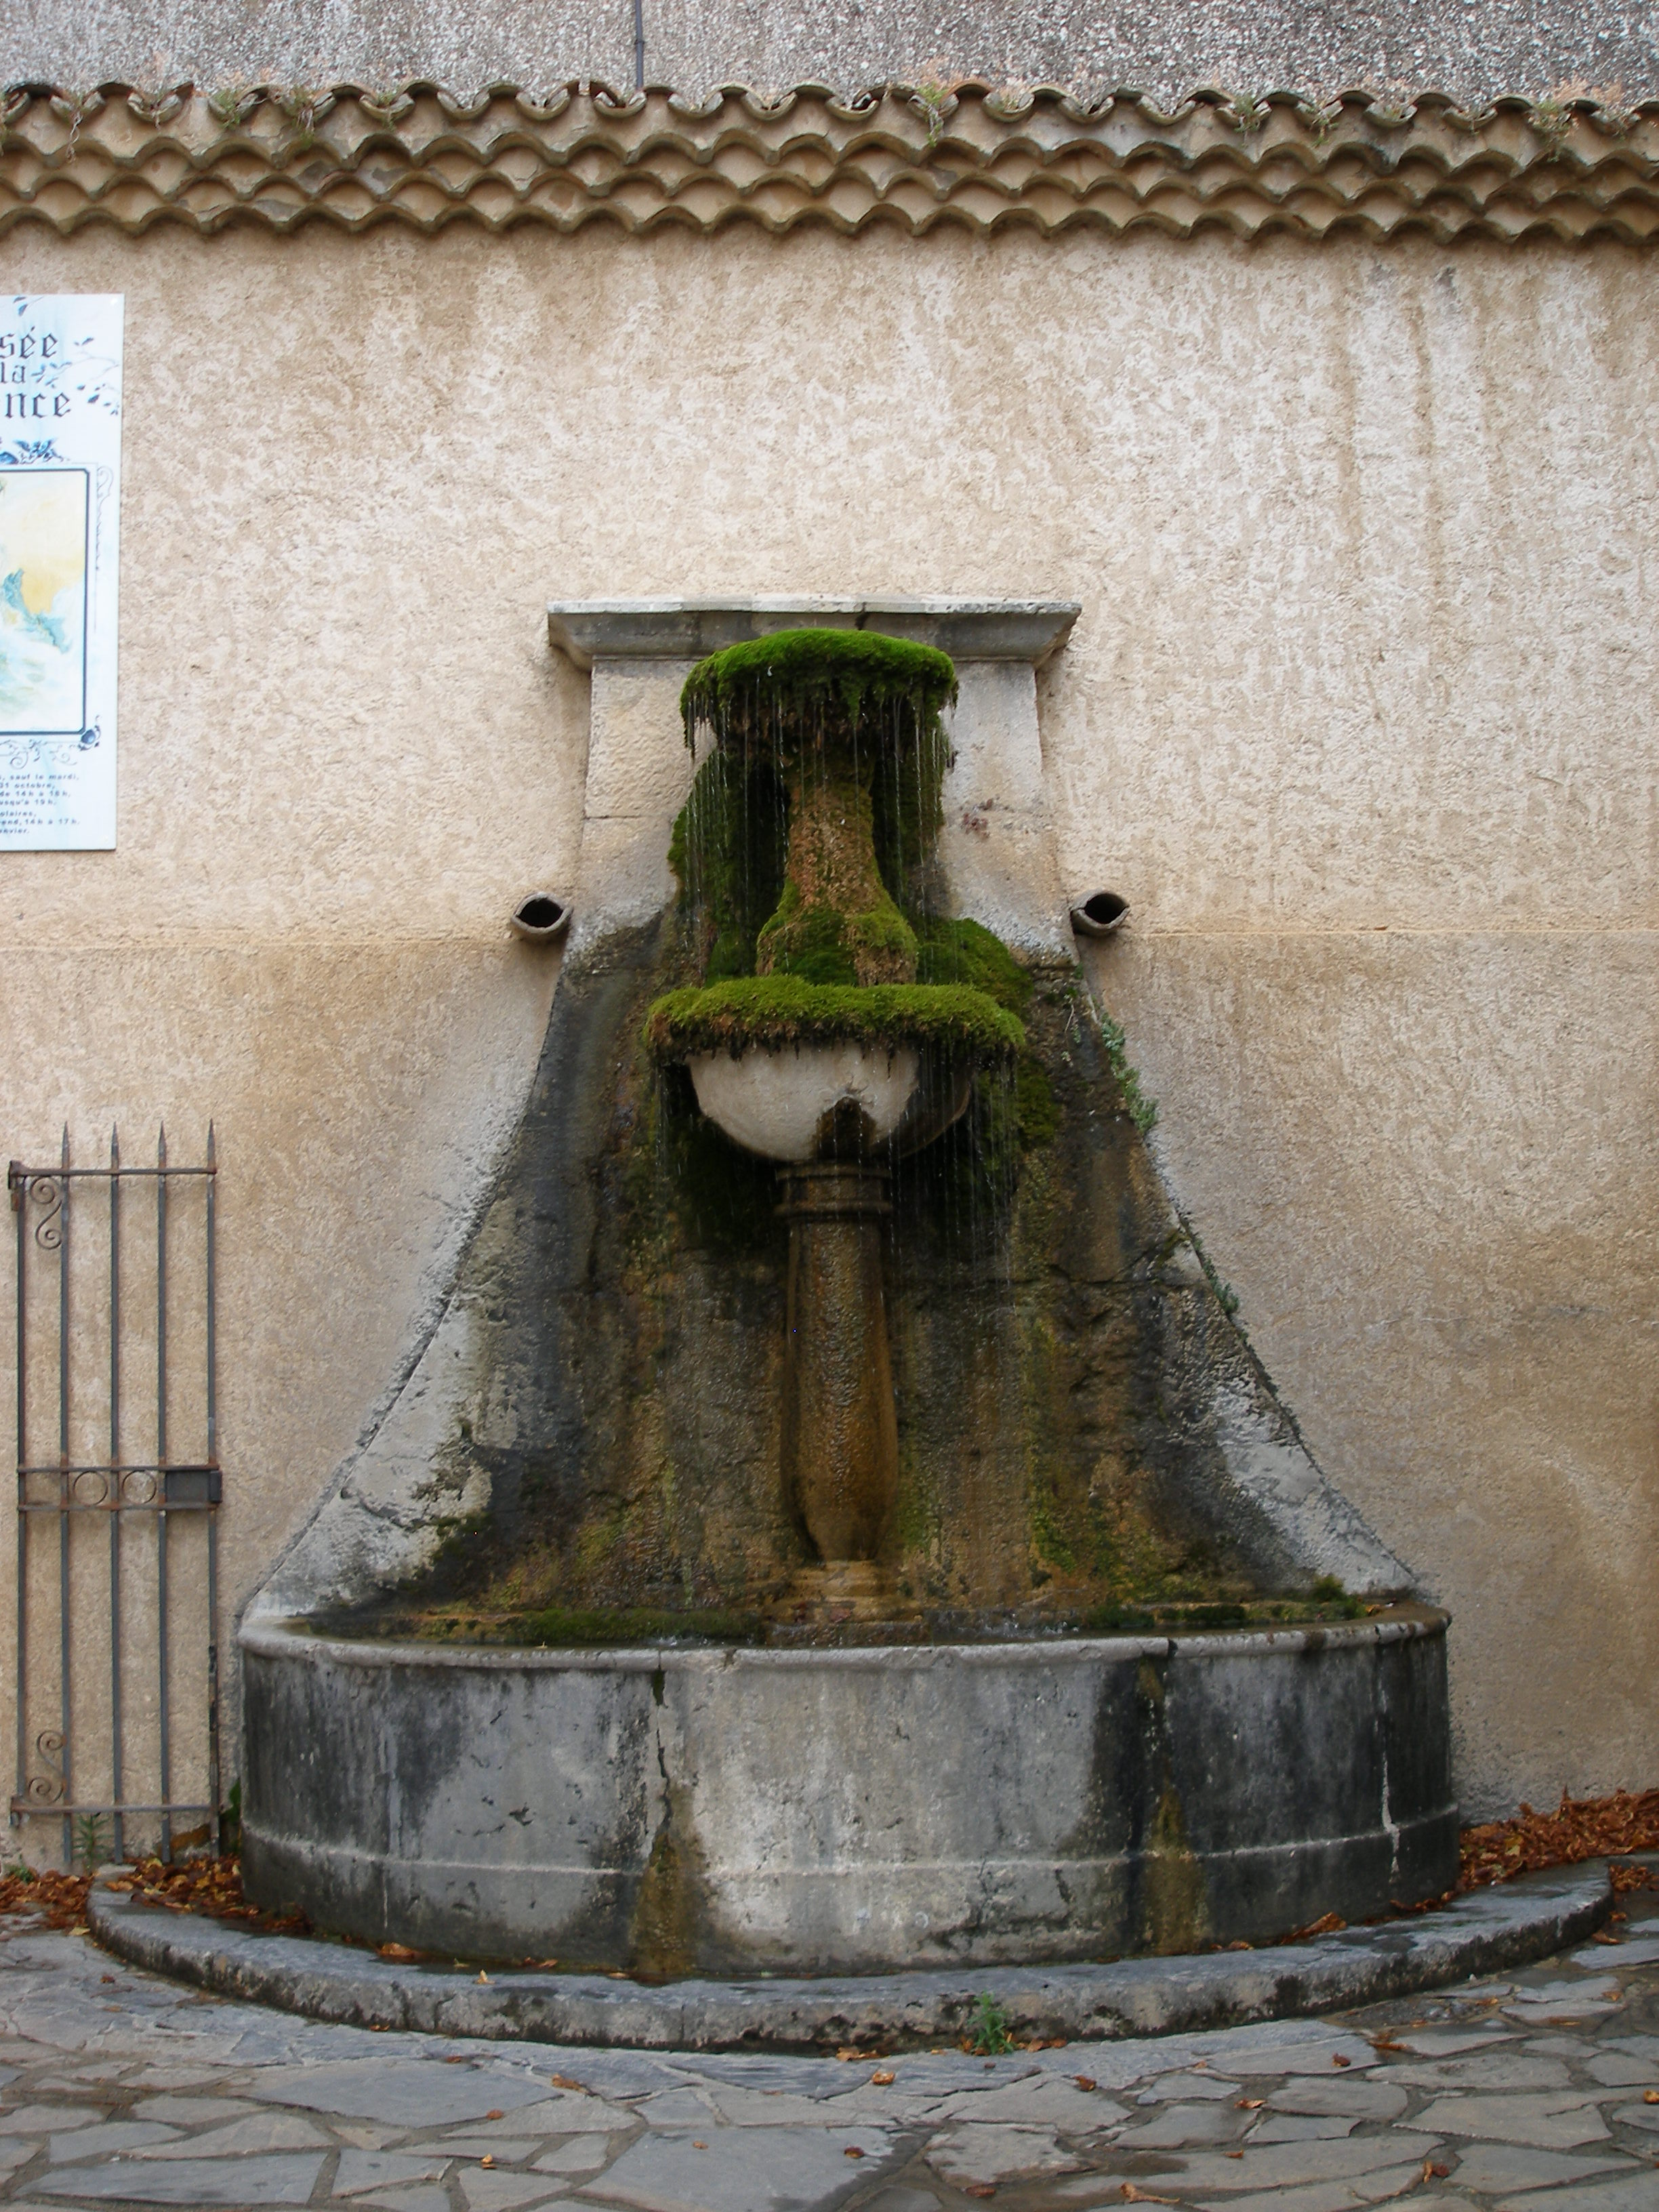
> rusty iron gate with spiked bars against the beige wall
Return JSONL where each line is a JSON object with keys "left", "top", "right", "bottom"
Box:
{"left": 7, "top": 1124, "right": 221, "bottom": 1865}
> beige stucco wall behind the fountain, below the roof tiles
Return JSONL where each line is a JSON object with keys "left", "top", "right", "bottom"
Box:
{"left": 0, "top": 211, "right": 1659, "bottom": 1831}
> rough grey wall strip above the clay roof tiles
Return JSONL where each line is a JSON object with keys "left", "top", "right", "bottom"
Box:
{"left": 7, "top": 0, "right": 1659, "bottom": 104}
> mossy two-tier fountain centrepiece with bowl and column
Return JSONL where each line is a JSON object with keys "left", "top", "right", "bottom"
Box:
{"left": 646, "top": 630, "right": 1024, "bottom": 1622}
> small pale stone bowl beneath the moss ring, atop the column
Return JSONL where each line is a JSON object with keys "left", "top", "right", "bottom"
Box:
{"left": 686, "top": 1038, "right": 922, "bottom": 1162}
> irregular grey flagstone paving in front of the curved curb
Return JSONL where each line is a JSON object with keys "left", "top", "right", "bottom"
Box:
{"left": 0, "top": 1891, "right": 1659, "bottom": 2212}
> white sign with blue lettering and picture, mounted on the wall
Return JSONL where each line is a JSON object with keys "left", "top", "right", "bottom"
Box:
{"left": 0, "top": 294, "right": 122, "bottom": 852}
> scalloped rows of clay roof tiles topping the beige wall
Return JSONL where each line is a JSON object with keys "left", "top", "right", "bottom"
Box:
{"left": 0, "top": 84, "right": 1659, "bottom": 243}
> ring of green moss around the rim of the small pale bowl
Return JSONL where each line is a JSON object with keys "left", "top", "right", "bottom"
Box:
{"left": 644, "top": 975, "right": 1024, "bottom": 1062}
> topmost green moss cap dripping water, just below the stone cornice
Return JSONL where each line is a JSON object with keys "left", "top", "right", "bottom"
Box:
{"left": 679, "top": 630, "right": 956, "bottom": 745}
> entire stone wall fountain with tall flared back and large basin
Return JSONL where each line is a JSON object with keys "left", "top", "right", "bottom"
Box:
{"left": 241, "top": 602, "right": 1456, "bottom": 1975}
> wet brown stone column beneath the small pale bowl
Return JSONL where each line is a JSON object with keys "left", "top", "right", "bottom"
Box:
{"left": 779, "top": 1162, "right": 898, "bottom": 1566}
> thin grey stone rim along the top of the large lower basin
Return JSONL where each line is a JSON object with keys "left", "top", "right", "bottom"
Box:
{"left": 237, "top": 1603, "right": 1451, "bottom": 1675}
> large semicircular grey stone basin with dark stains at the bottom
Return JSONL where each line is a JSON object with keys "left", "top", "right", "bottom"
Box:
{"left": 241, "top": 1606, "right": 1458, "bottom": 1975}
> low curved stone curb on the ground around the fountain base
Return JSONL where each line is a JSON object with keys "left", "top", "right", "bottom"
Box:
{"left": 86, "top": 1860, "right": 1612, "bottom": 2053}
